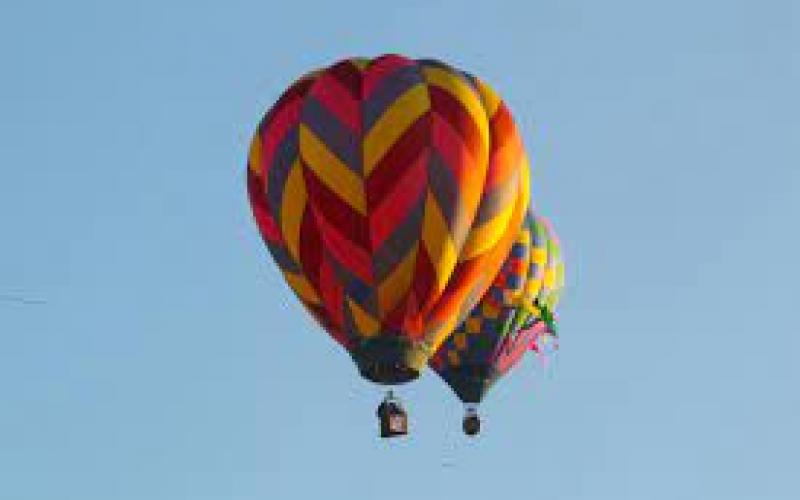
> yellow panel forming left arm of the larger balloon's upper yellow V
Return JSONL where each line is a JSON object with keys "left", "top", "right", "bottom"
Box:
{"left": 300, "top": 124, "right": 367, "bottom": 215}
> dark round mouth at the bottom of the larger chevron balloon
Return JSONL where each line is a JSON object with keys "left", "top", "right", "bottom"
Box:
{"left": 350, "top": 337, "right": 426, "bottom": 385}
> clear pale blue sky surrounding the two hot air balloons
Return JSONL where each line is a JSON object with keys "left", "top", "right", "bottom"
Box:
{"left": 0, "top": 0, "right": 800, "bottom": 500}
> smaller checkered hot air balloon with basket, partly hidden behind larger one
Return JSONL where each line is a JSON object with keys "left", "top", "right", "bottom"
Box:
{"left": 430, "top": 214, "right": 564, "bottom": 435}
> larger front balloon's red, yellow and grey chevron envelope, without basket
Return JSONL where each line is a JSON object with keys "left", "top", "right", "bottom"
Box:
{"left": 247, "top": 55, "right": 530, "bottom": 383}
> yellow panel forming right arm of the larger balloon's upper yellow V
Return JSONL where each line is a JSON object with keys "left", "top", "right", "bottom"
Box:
{"left": 362, "top": 83, "right": 431, "bottom": 176}
